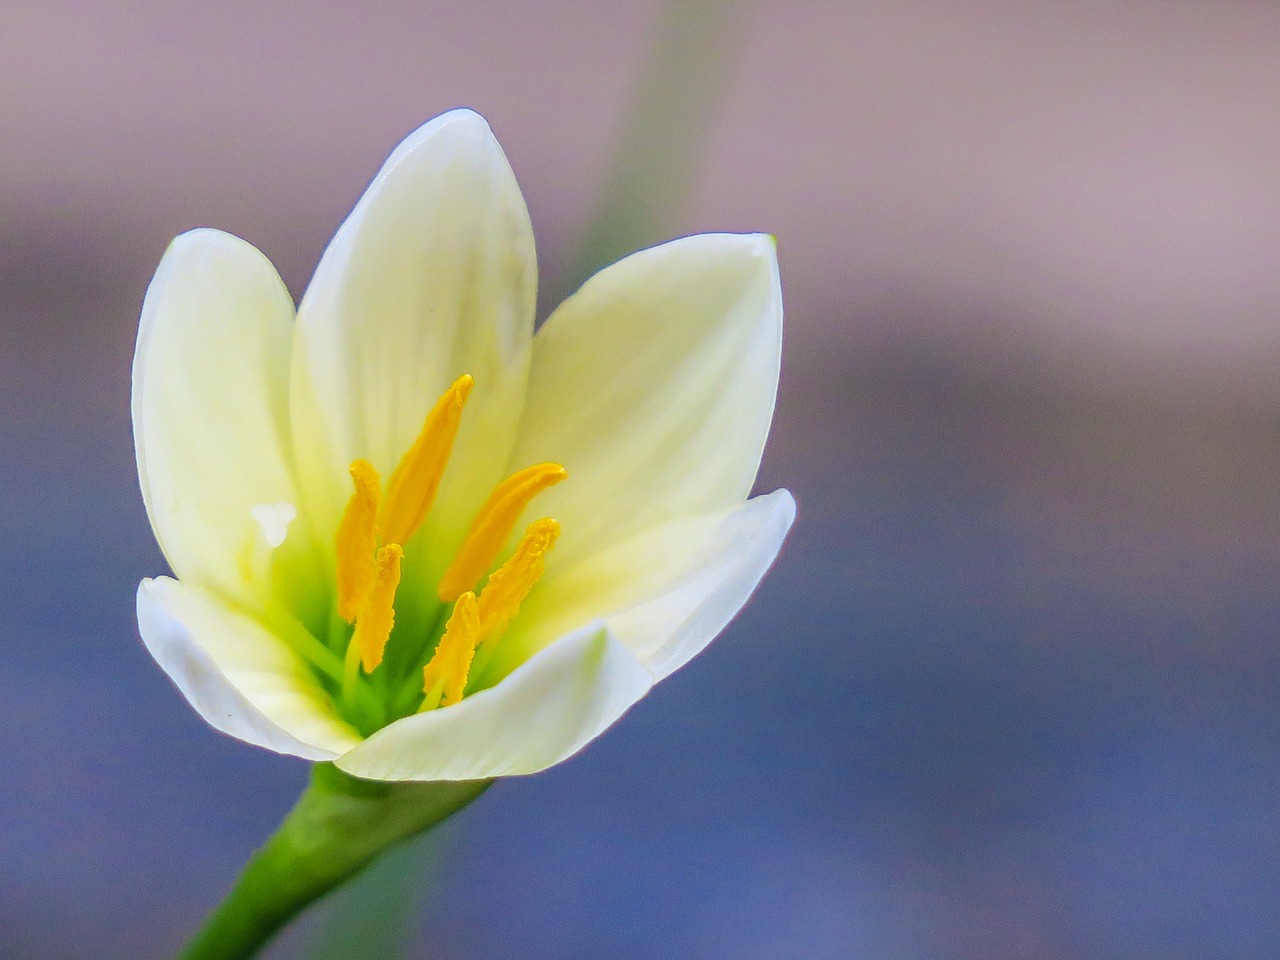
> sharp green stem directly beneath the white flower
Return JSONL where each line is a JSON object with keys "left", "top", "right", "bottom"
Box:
{"left": 182, "top": 763, "right": 493, "bottom": 960}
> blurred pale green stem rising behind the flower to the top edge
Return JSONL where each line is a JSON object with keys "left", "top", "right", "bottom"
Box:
{"left": 545, "top": 0, "right": 755, "bottom": 303}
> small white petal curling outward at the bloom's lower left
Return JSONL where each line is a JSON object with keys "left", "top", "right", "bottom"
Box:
{"left": 138, "top": 577, "right": 360, "bottom": 760}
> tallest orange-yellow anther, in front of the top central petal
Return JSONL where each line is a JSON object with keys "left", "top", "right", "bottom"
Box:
{"left": 379, "top": 374, "right": 475, "bottom": 544}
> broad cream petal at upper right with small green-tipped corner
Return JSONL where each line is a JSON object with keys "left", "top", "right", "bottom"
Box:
{"left": 513, "top": 234, "right": 782, "bottom": 568}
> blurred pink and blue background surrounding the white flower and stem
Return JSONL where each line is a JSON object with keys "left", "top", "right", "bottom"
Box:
{"left": 0, "top": 0, "right": 1280, "bottom": 960}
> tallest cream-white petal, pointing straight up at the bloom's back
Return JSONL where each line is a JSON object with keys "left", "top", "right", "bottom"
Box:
{"left": 292, "top": 110, "right": 536, "bottom": 552}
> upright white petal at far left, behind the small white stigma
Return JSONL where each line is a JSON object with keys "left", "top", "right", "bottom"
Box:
{"left": 133, "top": 229, "right": 297, "bottom": 595}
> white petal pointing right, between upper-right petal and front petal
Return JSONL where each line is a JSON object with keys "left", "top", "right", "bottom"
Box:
{"left": 499, "top": 490, "right": 795, "bottom": 681}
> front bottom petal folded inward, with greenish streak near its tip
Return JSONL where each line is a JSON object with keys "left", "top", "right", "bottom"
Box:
{"left": 335, "top": 625, "right": 653, "bottom": 781}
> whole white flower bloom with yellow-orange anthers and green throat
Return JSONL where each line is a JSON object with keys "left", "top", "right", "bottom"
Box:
{"left": 133, "top": 110, "right": 795, "bottom": 781}
